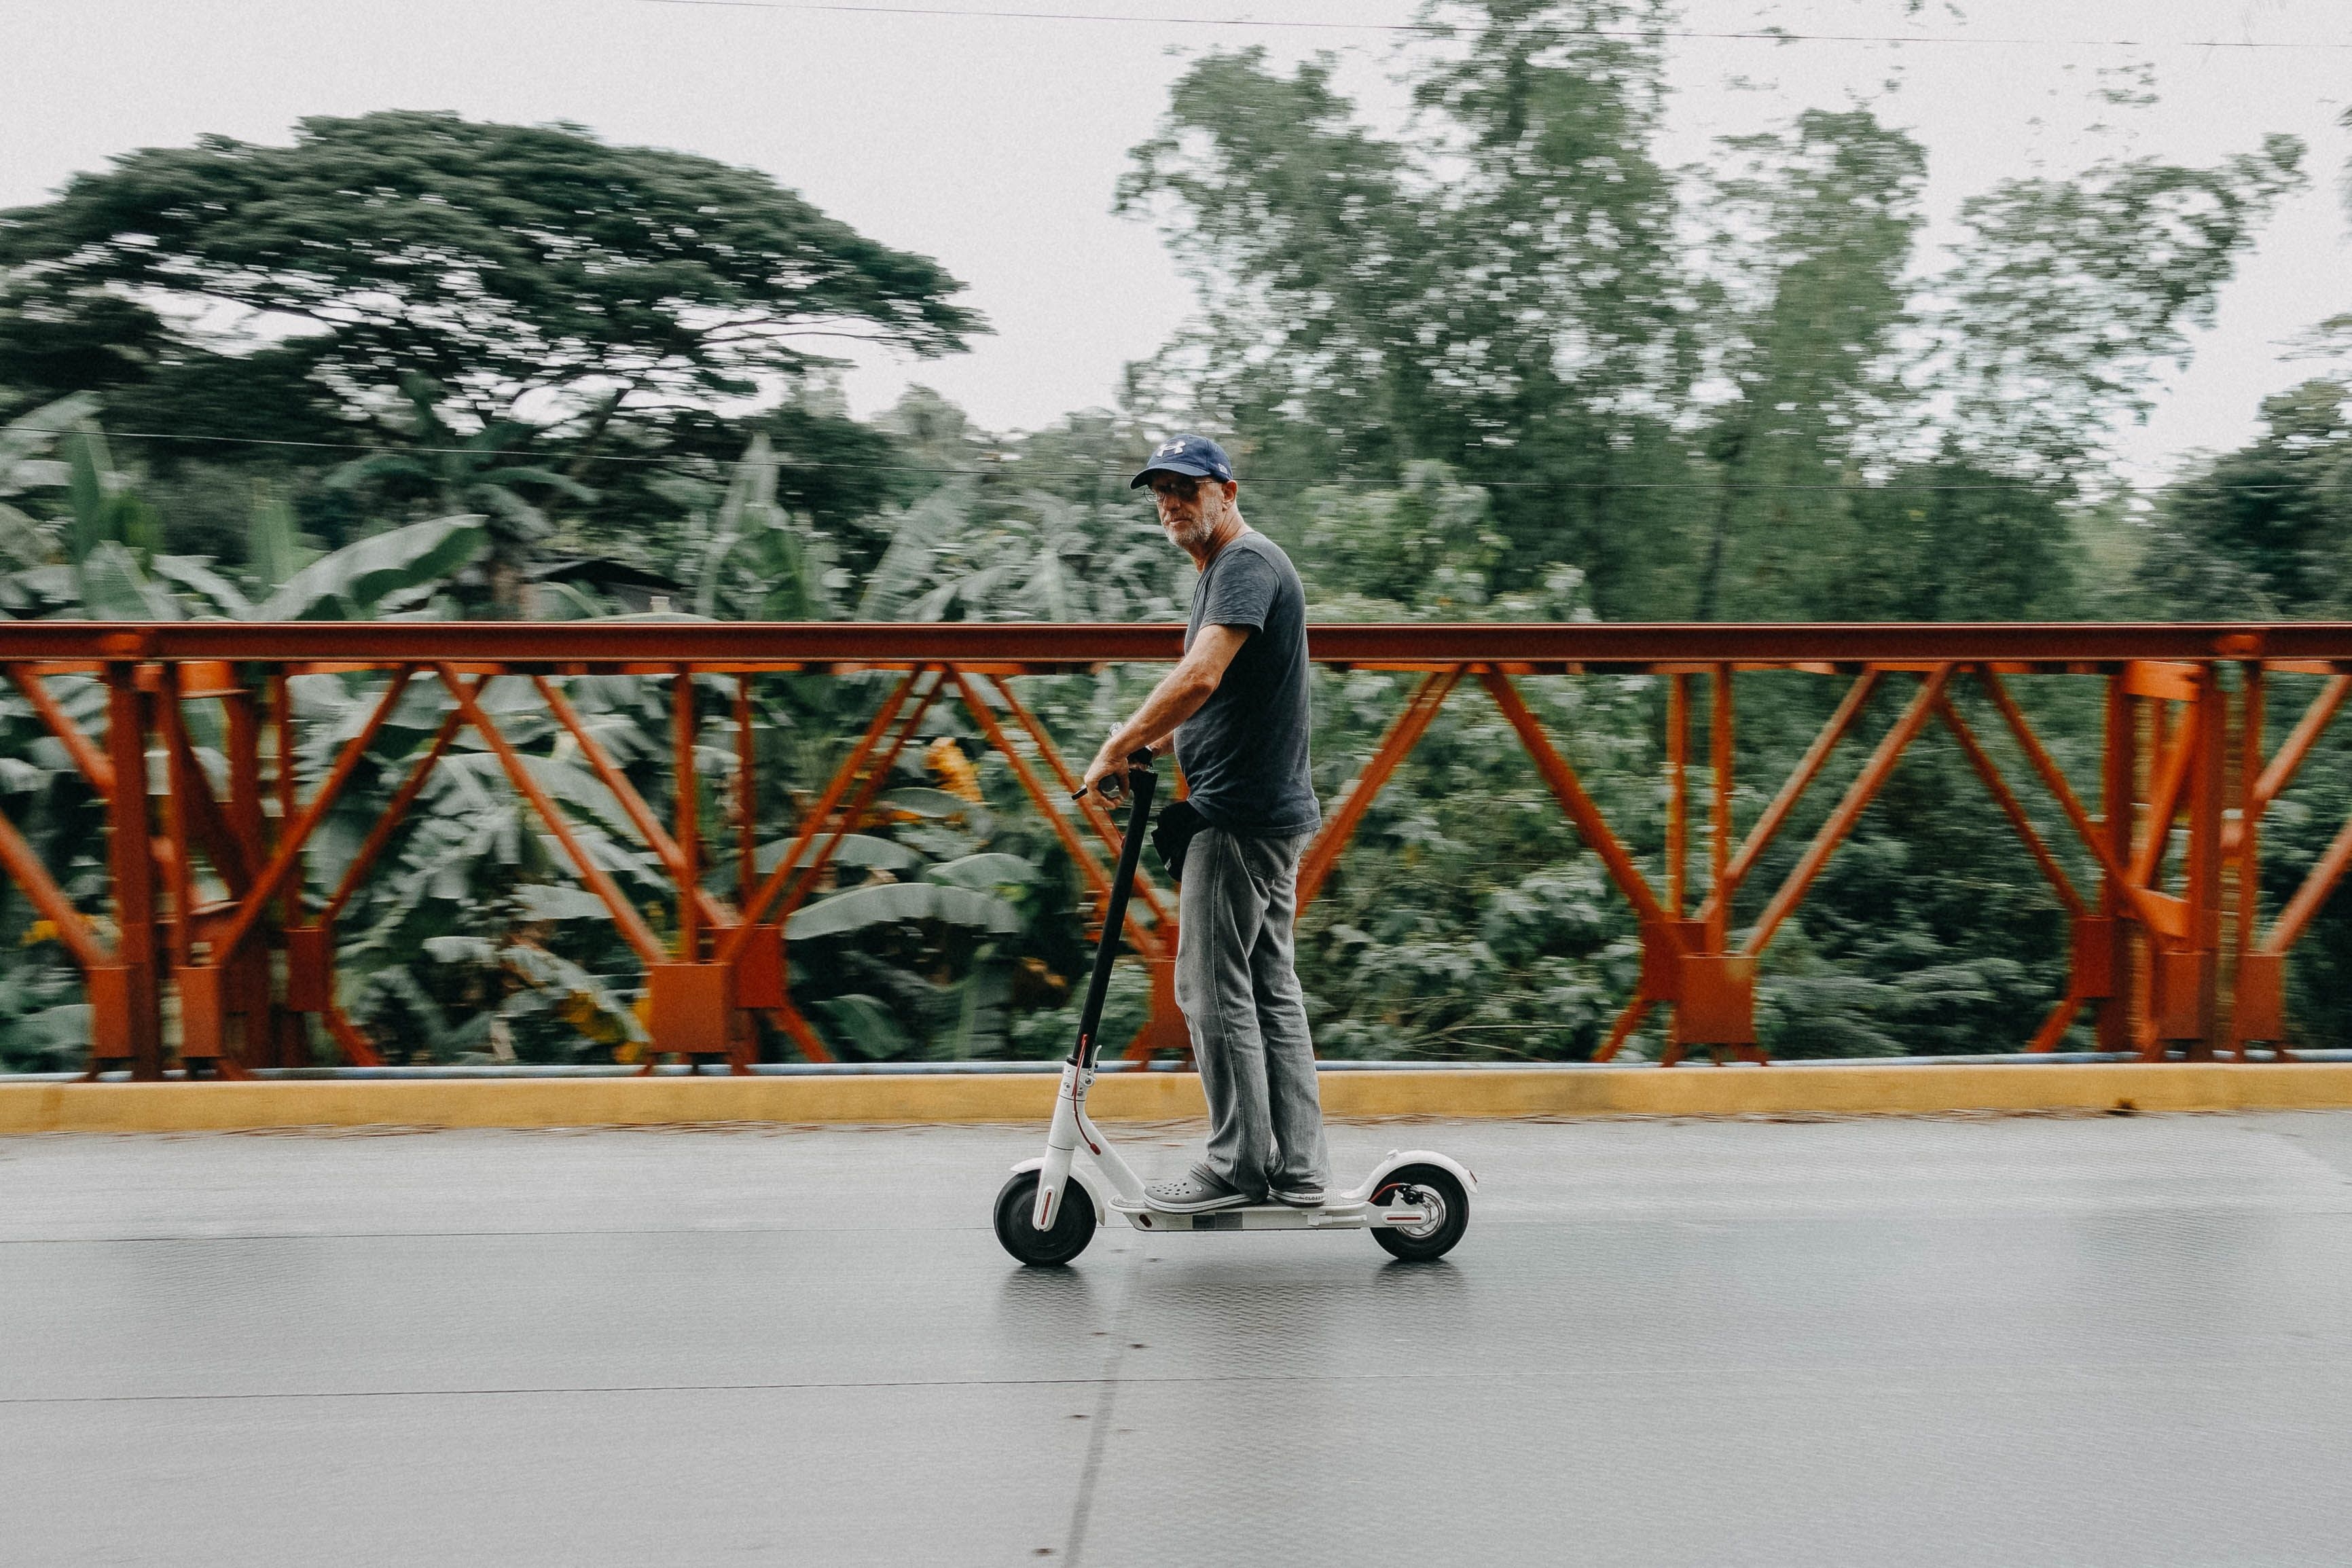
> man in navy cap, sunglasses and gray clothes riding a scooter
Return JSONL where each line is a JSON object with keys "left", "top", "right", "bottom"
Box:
{"left": 1087, "top": 435, "right": 1324, "bottom": 1213}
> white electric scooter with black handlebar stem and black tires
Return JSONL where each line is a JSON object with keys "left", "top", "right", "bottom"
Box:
{"left": 997, "top": 752, "right": 1477, "bottom": 1267}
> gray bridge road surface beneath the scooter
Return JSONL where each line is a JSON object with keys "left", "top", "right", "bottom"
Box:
{"left": 0, "top": 1112, "right": 2352, "bottom": 1568}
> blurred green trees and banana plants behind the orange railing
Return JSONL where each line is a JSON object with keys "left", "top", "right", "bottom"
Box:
{"left": 0, "top": 0, "right": 2352, "bottom": 1070}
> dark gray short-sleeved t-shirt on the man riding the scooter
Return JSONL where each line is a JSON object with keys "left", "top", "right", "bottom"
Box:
{"left": 1176, "top": 534, "right": 1322, "bottom": 837}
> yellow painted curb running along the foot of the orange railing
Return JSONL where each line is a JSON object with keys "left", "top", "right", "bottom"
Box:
{"left": 0, "top": 1063, "right": 2352, "bottom": 1133}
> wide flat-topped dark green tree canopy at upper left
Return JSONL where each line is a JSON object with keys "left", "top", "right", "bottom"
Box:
{"left": 0, "top": 113, "right": 981, "bottom": 435}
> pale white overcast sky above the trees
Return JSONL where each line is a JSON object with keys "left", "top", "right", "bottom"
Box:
{"left": 0, "top": 0, "right": 2352, "bottom": 479}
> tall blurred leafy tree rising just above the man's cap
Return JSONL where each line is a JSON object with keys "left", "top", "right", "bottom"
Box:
{"left": 1119, "top": 0, "right": 1691, "bottom": 609}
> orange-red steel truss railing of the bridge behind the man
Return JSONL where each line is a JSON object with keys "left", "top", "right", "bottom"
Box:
{"left": 0, "top": 621, "right": 2352, "bottom": 1079}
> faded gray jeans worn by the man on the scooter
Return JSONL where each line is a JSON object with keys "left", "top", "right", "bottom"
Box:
{"left": 1176, "top": 828, "right": 1326, "bottom": 1197}
